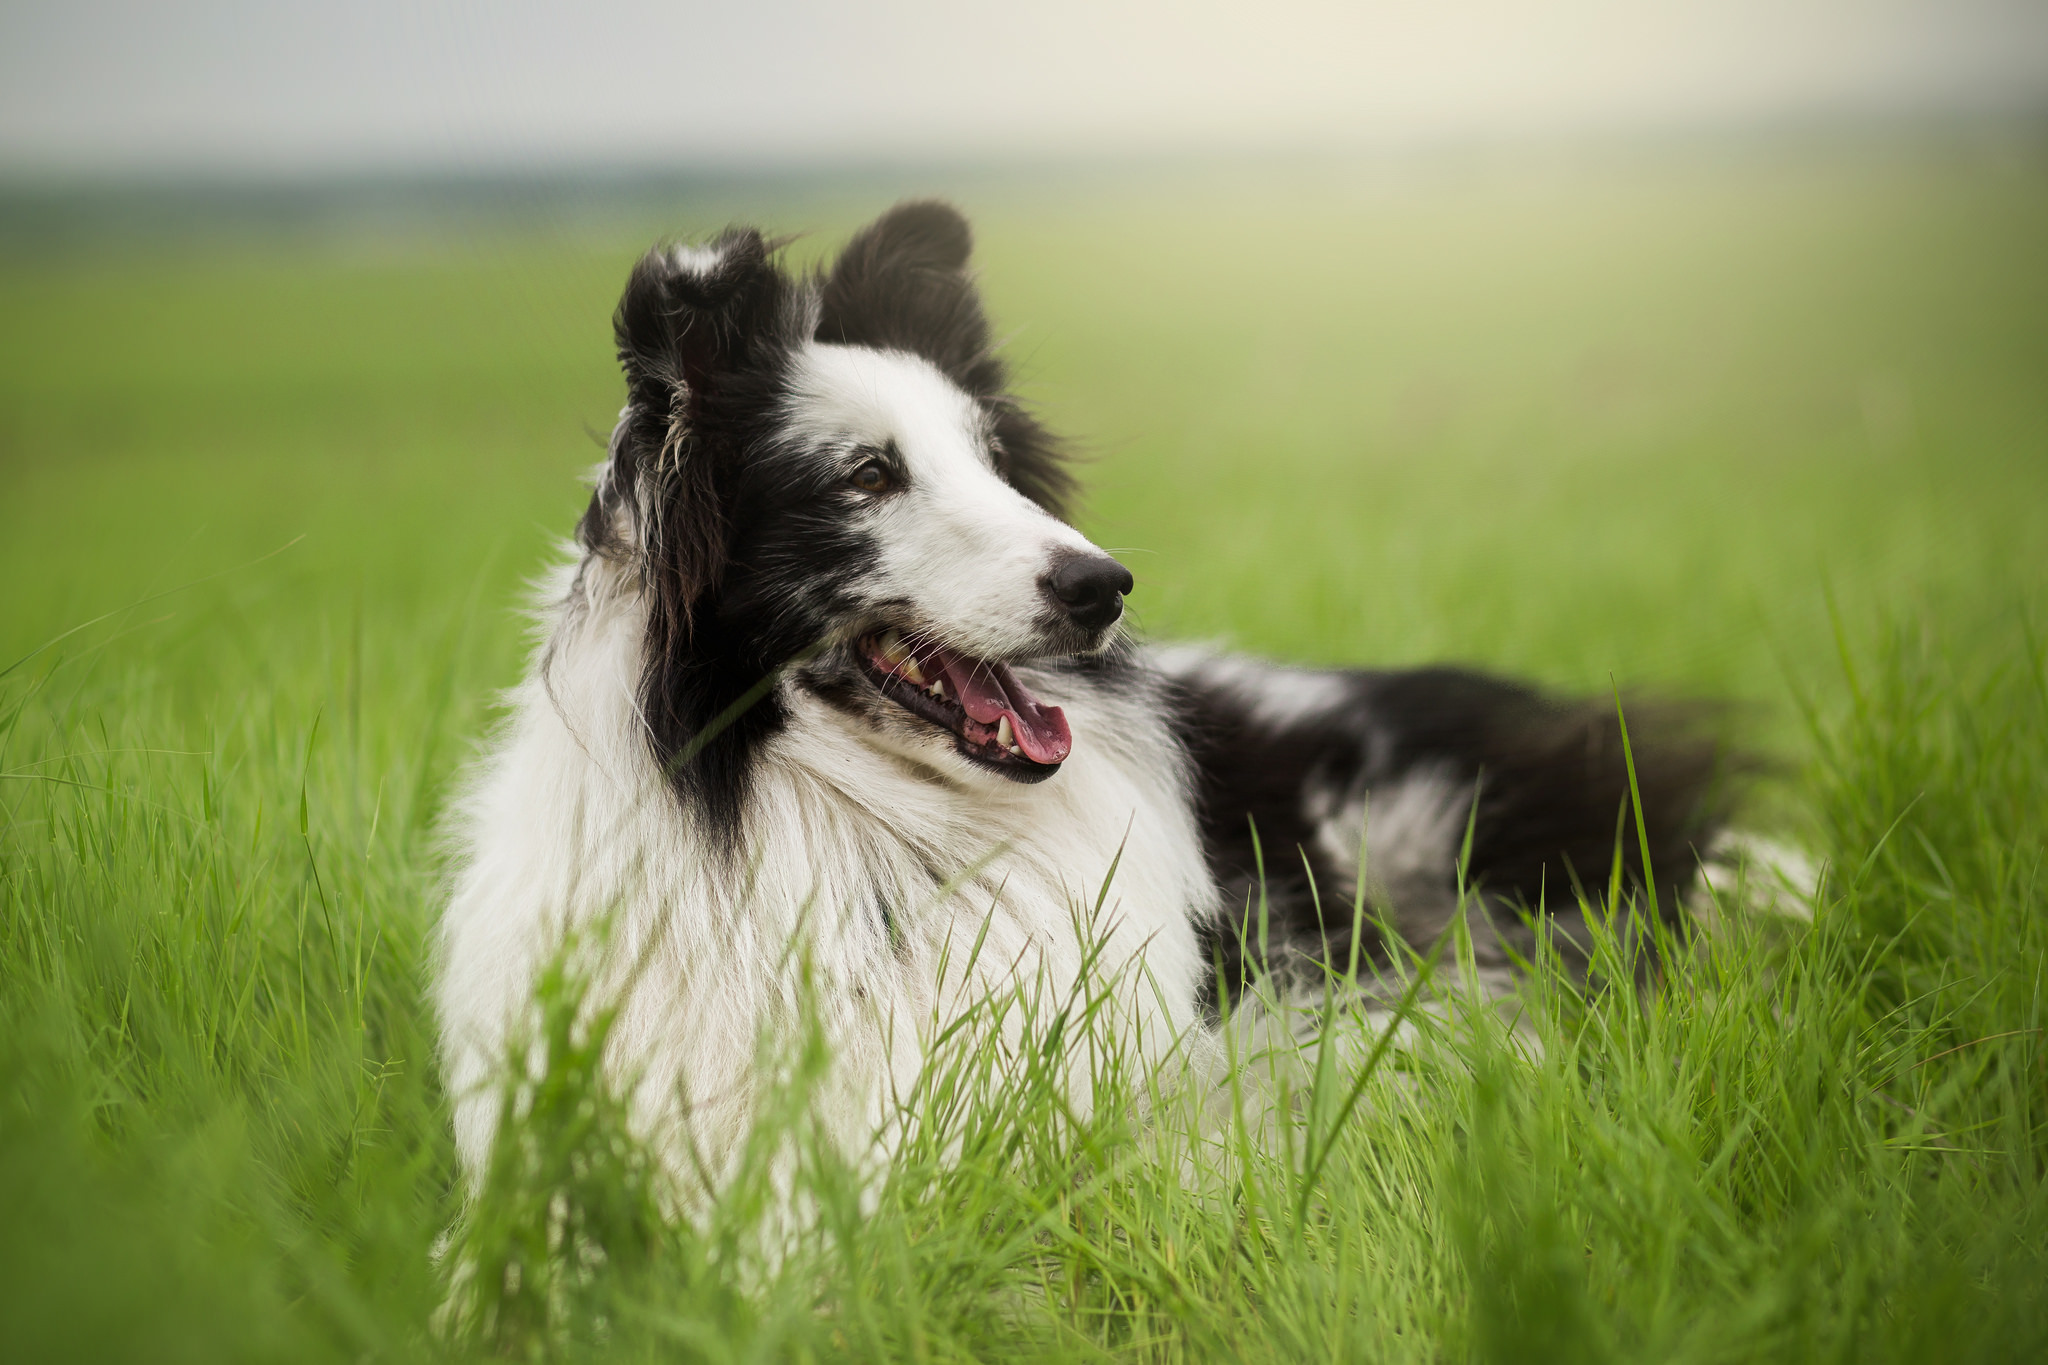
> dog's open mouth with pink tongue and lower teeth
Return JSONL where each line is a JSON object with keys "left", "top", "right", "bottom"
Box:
{"left": 856, "top": 630, "right": 1073, "bottom": 782}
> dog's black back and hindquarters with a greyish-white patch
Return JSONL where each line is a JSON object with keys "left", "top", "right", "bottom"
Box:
{"left": 1155, "top": 649, "right": 1745, "bottom": 988}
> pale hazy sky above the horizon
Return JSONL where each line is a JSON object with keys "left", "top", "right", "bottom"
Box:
{"left": 0, "top": 0, "right": 2048, "bottom": 176}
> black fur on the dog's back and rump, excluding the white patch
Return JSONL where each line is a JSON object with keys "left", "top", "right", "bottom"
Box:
{"left": 1178, "top": 667, "right": 1745, "bottom": 990}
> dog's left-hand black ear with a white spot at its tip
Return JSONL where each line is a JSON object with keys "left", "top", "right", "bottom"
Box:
{"left": 580, "top": 227, "right": 809, "bottom": 605}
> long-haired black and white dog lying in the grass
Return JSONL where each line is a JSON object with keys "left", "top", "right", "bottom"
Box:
{"left": 436, "top": 203, "right": 1722, "bottom": 1169}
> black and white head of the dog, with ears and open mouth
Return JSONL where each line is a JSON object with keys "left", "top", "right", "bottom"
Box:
{"left": 580, "top": 203, "right": 1130, "bottom": 819}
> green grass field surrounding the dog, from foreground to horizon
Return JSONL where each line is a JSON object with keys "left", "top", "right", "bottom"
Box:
{"left": 12, "top": 145, "right": 2048, "bottom": 1361}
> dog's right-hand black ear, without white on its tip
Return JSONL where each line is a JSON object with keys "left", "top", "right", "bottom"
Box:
{"left": 817, "top": 199, "right": 1073, "bottom": 516}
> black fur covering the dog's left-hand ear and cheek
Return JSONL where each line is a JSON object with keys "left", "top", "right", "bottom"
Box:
{"left": 580, "top": 229, "right": 862, "bottom": 837}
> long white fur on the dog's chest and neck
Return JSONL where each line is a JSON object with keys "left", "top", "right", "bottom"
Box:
{"left": 438, "top": 559, "right": 1217, "bottom": 1169}
